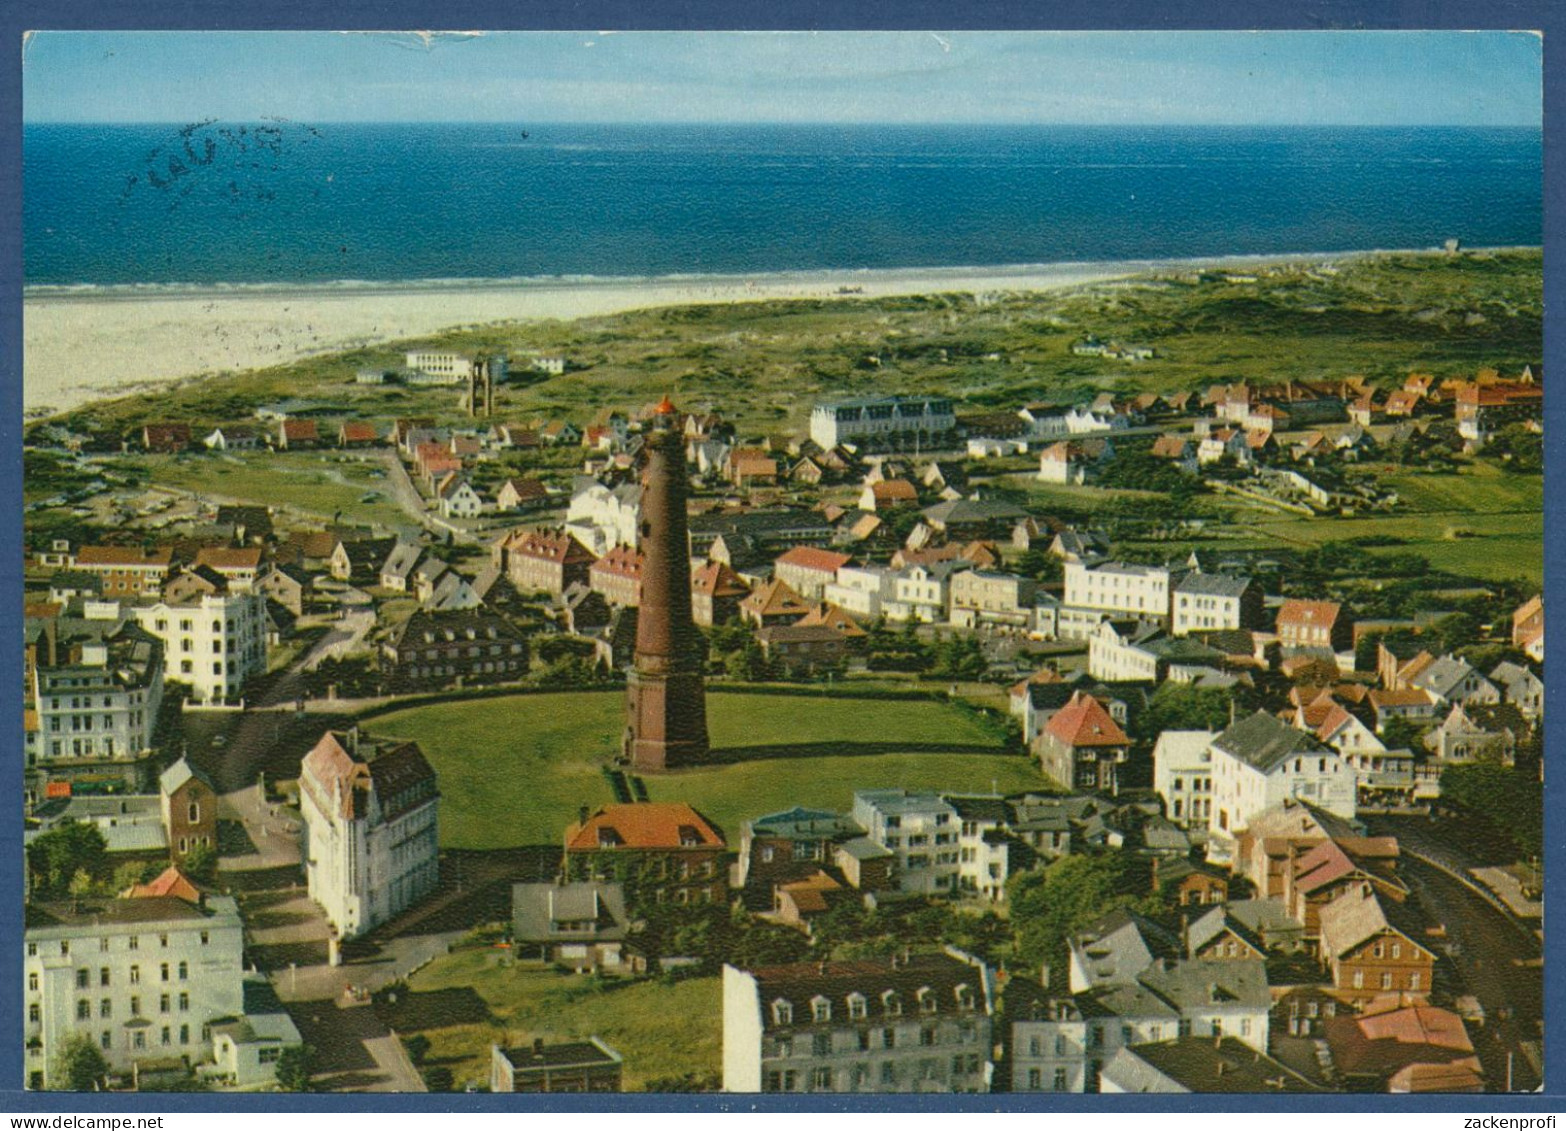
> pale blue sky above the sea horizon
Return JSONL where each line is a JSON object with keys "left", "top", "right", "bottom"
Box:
{"left": 22, "top": 31, "right": 1543, "bottom": 127}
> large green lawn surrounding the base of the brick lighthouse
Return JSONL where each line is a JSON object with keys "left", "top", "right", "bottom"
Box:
{"left": 366, "top": 692, "right": 1043, "bottom": 849}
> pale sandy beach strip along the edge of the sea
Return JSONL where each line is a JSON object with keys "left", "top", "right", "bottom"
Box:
{"left": 22, "top": 248, "right": 1540, "bottom": 417}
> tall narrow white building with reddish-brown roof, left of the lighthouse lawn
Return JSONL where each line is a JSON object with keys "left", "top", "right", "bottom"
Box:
{"left": 299, "top": 727, "right": 440, "bottom": 938}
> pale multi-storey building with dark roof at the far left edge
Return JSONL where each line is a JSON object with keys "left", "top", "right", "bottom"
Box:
{"left": 27, "top": 617, "right": 163, "bottom": 783}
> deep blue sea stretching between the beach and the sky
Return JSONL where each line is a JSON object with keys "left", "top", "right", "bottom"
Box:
{"left": 23, "top": 121, "right": 1543, "bottom": 287}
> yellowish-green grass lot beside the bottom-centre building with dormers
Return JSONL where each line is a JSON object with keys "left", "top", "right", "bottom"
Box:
{"left": 385, "top": 949, "right": 723, "bottom": 1092}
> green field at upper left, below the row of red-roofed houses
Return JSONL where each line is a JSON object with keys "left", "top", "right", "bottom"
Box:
{"left": 114, "top": 451, "right": 412, "bottom": 528}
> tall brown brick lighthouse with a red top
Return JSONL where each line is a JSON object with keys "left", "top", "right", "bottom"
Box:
{"left": 625, "top": 396, "right": 708, "bottom": 771}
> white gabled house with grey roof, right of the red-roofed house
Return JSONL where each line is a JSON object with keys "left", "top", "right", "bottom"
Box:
{"left": 1207, "top": 711, "right": 1358, "bottom": 860}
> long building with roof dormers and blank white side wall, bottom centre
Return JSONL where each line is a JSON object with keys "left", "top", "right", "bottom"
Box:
{"left": 723, "top": 948, "right": 994, "bottom": 1095}
